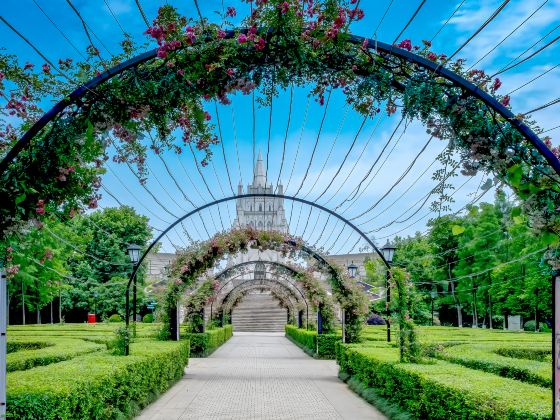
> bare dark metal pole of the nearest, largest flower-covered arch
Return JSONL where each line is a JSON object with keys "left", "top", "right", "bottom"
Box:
{"left": 0, "top": 32, "right": 560, "bottom": 175}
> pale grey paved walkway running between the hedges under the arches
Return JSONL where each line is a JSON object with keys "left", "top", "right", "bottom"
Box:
{"left": 138, "top": 333, "right": 385, "bottom": 420}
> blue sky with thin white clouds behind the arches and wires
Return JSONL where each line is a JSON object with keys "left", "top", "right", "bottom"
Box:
{"left": 0, "top": 0, "right": 560, "bottom": 253}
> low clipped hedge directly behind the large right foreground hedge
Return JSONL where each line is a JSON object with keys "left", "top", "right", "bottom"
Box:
{"left": 434, "top": 343, "right": 552, "bottom": 388}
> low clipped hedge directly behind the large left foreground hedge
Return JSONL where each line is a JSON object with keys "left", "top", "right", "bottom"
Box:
{"left": 6, "top": 337, "right": 106, "bottom": 372}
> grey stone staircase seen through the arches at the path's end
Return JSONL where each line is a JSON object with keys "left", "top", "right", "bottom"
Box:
{"left": 231, "top": 293, "right": 288, "bottom": 332}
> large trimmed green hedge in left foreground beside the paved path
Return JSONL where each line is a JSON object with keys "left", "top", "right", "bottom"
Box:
{"left": 7, "top": 340, "right": 189, "bottom": 420}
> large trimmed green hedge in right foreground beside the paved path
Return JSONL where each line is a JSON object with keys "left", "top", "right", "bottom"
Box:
{"left": 337, "top": 345, "right": 552, "bottom": 420}
